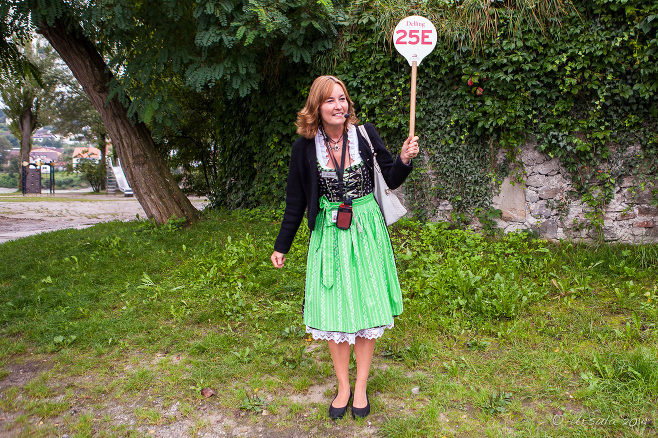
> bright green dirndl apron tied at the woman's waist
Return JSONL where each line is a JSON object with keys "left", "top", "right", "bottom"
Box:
{"left": 304, "top": 193, "right": 402, "bottom": 333}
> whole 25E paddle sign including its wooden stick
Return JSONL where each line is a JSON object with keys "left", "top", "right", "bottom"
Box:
{"left": 393, "top": 15, "right": 437, "bottom": 135}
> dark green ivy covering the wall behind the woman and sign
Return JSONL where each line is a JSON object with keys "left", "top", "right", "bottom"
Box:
{"left": 202, "top": 0, "right": 658, "bottom": 238}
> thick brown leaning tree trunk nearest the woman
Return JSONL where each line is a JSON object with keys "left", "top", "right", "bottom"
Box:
{"left": 38, "top": 19, "right": 199, "bottom": 224}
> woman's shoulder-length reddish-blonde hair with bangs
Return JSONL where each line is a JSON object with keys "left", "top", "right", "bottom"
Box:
{"left": 295, "top": 76, "right": 359, "bottom": 139}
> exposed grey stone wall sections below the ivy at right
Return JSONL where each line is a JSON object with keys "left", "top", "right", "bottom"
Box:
{"left": 428, "top": 145, "right": 658, "bottom": 243}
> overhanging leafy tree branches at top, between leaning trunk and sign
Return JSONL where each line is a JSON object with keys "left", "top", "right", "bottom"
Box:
{"left": 97, "top": 0, "right": 343, "bottom": 132}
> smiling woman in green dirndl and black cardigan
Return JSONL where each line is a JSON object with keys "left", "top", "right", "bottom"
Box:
{"left": 271, "top": 76, "right": 418, "bottom": 419}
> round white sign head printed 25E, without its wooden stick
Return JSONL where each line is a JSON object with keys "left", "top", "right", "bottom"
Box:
{"left": 393, "top": 15, "right": 437, "bottom": 65}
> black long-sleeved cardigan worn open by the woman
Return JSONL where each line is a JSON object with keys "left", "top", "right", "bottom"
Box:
{"left": 274, "top": 123, "right": 413, "bottom": 254}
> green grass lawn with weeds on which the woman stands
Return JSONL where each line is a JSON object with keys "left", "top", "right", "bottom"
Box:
{"left": 0, "top": 210, "right": 658, "bottom": 437}
